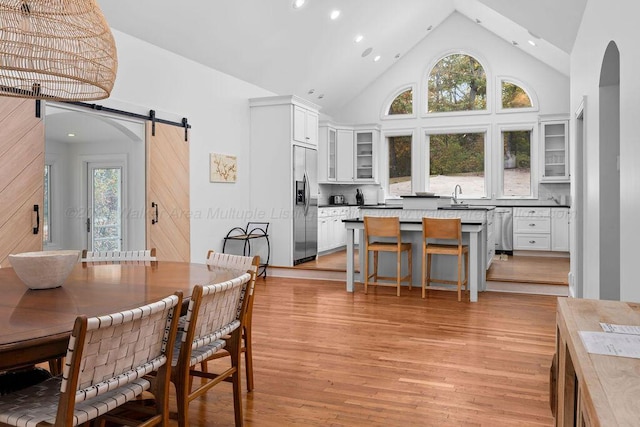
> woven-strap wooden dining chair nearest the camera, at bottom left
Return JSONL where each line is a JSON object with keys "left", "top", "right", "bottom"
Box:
{"left": 0, "top": 292, "right": 182, "bottom": 427}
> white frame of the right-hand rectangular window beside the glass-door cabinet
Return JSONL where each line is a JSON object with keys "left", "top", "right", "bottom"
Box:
{"left": 495, "top": 122, "right": 540, "bottom": 200}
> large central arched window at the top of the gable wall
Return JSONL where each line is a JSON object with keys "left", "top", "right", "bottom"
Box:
{"left": 427, "top": 53, "right": 487, "bottom": 113}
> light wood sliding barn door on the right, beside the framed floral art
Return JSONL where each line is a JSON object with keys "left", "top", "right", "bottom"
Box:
{"left": 146, "top": 122, "right": 191, "bottom": 262}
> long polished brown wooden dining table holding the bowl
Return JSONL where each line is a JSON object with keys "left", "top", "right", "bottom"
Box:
{"left": 0, "top": 261, "right": 245, "bottom": 371}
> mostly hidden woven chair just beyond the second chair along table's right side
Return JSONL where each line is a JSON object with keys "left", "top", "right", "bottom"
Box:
{"left": 201, "top": 250, "right": 260, "bottom": 391}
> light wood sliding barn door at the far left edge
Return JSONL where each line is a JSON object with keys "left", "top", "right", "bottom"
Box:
{"left": 0, "top": 96, "right": 44, "bottom": 267}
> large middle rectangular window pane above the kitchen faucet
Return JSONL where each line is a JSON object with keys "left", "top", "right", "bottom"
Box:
{"left": 429, "top": 133, "right": 486, "bottom": 198}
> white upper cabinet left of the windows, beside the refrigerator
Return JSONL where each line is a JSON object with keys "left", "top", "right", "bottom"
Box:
{"left": 318, "top": 123, "right": 380, "bottom": 184}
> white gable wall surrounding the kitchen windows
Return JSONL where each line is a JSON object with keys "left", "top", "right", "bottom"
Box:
{"left": 333, "top": 13, "right": 569, "bottom": 203}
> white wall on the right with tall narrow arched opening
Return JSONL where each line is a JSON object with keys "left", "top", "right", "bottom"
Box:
{"left": 571, "top": 0, "right": 640, "bottom": 301}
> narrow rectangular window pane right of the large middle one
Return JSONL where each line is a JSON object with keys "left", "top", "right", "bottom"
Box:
{"left": 502, "top": 130, "right": 531, "bottom": 196}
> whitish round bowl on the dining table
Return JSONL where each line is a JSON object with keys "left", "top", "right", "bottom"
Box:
{"left": 9, "top": 250, "right": 80, "bottom": 289}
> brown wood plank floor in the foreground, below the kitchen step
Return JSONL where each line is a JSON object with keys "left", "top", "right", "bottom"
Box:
{"left": 178, "top": 277, "right": 556, "bottom": 427}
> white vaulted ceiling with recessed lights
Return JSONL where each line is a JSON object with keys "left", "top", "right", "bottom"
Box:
{"left": 99, "top": 0, "right": 587, "bottom": 115}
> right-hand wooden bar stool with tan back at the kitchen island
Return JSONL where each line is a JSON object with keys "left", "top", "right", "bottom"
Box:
{"left": 422, "top": 218, "right": 469, "bottom": 301}
